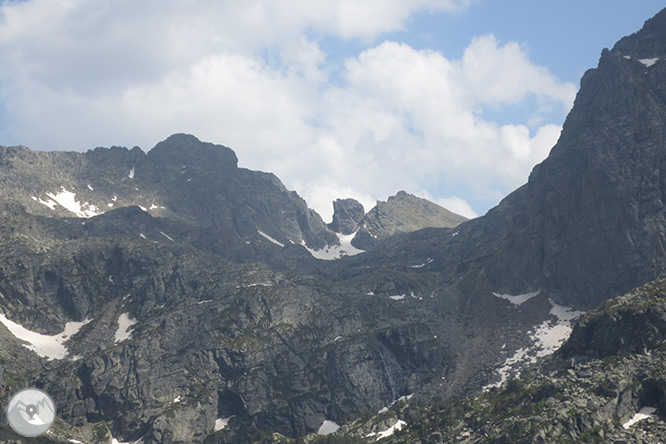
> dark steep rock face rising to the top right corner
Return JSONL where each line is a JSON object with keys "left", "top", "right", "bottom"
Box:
{"left": 352, "top": 11, "right": 666, "bottom": 308}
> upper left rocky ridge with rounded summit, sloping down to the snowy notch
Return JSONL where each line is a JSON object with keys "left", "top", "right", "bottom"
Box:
{"left": 0, "top": 134, "right": 339, "bottom": 257}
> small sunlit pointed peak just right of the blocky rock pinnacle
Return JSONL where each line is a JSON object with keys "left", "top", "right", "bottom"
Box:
{"left": 352, "top": 191, "right": 467, "bottom": 250}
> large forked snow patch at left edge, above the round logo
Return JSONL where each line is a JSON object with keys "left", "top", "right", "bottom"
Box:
{"left": 0, "top": 314, "right": 91, "bottom": 361}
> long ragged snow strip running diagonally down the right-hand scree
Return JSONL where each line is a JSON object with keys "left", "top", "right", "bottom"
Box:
{"left": 483, "top": 299, "right": 584, "bottom": 391}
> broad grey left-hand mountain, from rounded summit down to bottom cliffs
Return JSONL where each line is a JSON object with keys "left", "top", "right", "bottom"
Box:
{"left": 0, "top": 134, "right": 462, "bottom": 442}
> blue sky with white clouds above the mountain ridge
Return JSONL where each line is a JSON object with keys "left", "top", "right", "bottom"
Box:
{"left": 0, "top": 0, "right": 663, "bottom": 220}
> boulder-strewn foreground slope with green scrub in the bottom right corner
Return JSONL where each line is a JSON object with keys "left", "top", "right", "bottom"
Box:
{"left": 286, "top": 278, "right": 666, "bottom": 444}
